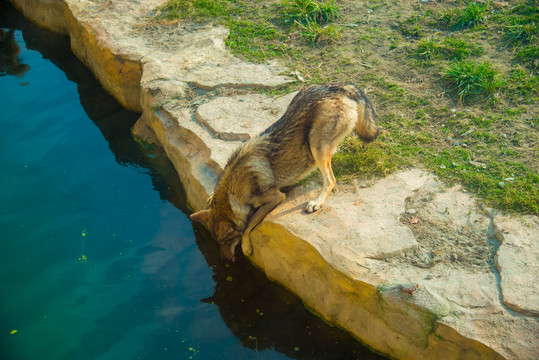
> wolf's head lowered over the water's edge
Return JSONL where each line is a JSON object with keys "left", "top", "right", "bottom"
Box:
{"left": 189, "top": 209, "right": 242, "bottom": 261}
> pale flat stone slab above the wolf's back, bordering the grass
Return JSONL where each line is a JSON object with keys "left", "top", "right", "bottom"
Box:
{"left": 135, "top": 24, "right": 291, "bottom": 90}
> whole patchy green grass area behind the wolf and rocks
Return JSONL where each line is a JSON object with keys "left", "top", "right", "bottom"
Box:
{"left": 154, "top": 0, "right": 539, "bottom": 214}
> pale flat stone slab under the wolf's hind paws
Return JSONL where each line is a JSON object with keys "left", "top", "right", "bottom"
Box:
{"left": 267, "top": 170, "right": 433, "bottom": 268}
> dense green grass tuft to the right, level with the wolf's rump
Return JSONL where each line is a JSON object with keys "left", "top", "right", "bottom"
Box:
{"left": 442, "top": 61, "right": 505, "bottom": 103}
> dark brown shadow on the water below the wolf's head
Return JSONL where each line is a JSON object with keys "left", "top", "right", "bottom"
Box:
{"left": 194, "top": 224, "right": 384, "bottom": 359}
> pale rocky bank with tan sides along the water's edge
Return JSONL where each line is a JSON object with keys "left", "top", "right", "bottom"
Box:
{"left": 11, "top": 0, "right": 539, "bottom": 359}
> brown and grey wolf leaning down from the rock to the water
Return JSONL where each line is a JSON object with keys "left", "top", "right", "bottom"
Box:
{"left": 190, "top": 85, "right": 380, "bottom": 261}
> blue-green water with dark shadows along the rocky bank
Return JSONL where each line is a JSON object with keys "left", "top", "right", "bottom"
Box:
{"left": 0, "top": 2, "right": 386, "bottom": 360}
